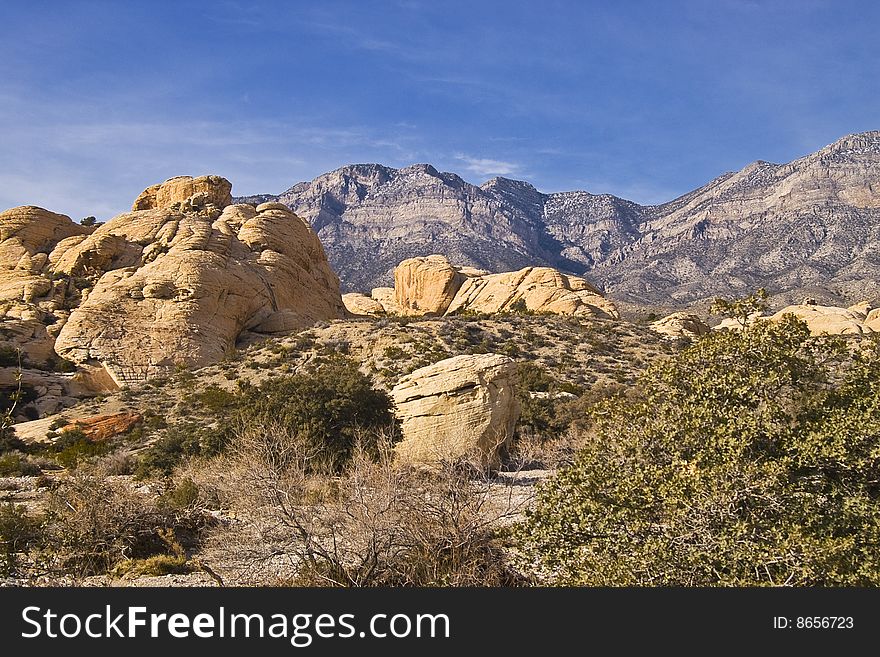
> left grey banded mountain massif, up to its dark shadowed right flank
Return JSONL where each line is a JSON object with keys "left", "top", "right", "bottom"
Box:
{"left": 241, "top": 164, "right": 576, "bottom": 291}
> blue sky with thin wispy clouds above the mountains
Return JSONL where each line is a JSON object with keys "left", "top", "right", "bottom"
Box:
{"left": 0, "top": 0, "right": 880, "bottom": 219}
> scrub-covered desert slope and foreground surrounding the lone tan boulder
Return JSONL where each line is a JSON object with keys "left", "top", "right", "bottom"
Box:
{"left": 0, "top": 294, "right": 880, "bottom": 586}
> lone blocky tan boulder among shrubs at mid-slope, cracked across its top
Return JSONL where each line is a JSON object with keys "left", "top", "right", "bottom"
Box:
{"left": 391, "top": 354, "right": 519, "bottom": 466}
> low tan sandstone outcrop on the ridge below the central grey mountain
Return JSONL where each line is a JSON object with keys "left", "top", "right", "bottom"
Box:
{"left": 346, "top": 255, "right": 619, "bottom": 319}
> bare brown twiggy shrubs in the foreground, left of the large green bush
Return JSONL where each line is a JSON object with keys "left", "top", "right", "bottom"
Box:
{"left": 211, "top": 423, "right": 522, "bottom": 587}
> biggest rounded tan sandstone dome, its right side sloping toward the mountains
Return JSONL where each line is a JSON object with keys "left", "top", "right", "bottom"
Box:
{"left": 55, "top": 200, "right": 344, "bottom": 385}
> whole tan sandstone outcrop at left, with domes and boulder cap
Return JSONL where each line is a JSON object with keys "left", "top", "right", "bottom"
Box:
{"left": 0, "top": 176, "right": 345, "bottom": 398}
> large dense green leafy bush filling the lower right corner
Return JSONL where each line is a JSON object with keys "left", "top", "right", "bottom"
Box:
{"left": 519, "top": 316, "right": 880, "bottom": 586}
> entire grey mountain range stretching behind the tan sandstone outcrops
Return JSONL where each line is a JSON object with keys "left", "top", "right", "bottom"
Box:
{"left": 242, "top": 132, "right": 880, "bottom": 304}
